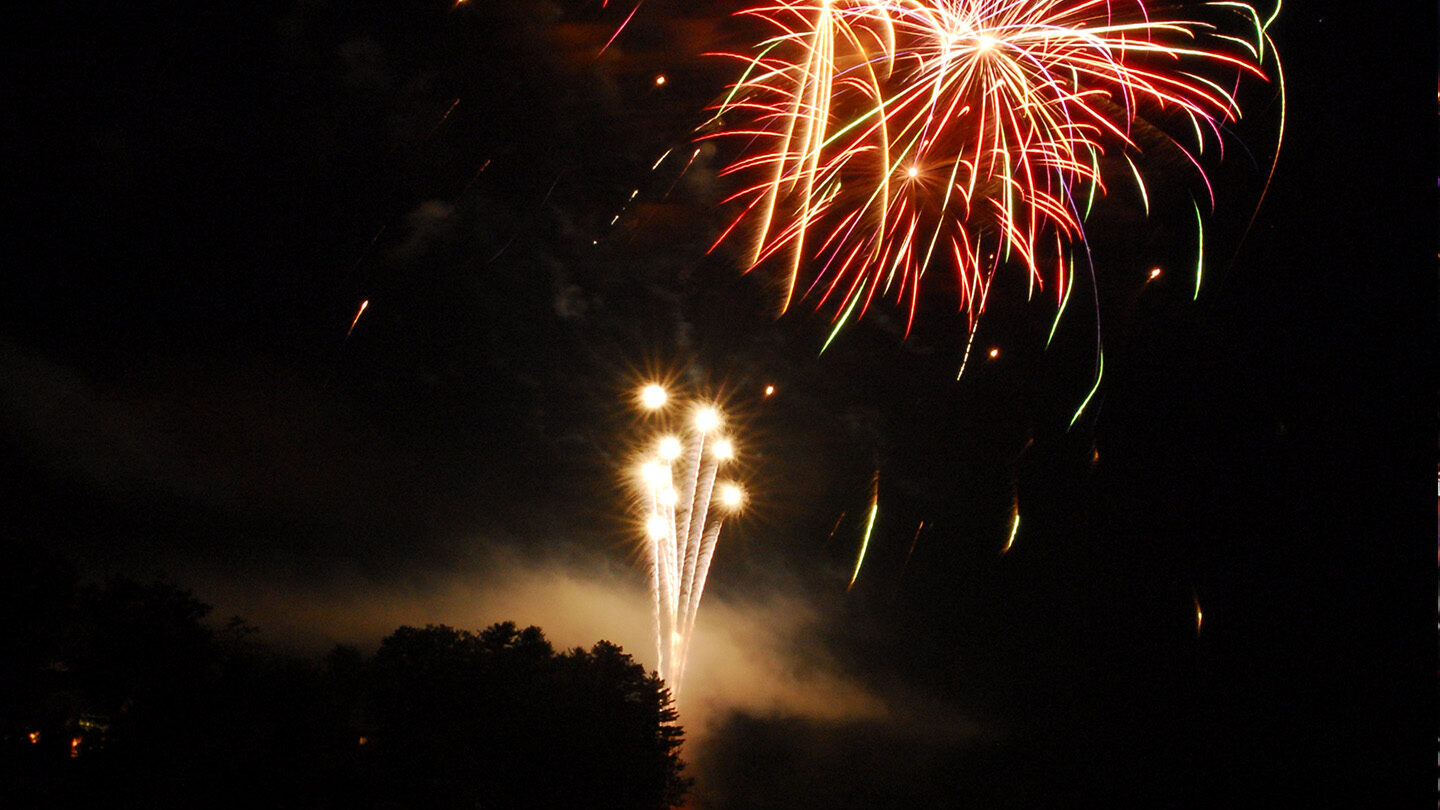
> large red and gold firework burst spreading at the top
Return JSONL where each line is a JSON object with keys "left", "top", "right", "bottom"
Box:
{"left": 701, "top": 0, "right": 1283, "bottom": 350}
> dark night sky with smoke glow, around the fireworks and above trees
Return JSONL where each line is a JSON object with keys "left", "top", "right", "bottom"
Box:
{"left": 0, "top": 0, "right": 1436, "bottom": 807}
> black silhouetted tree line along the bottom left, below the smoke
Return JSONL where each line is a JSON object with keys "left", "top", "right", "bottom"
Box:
{"left": 0, "top": 552, "right": 690, "bottom": 810}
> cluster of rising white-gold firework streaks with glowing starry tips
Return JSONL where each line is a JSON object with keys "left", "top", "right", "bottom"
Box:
{"left": 639, "top": 385, "right": 744, "bottom": 695}
